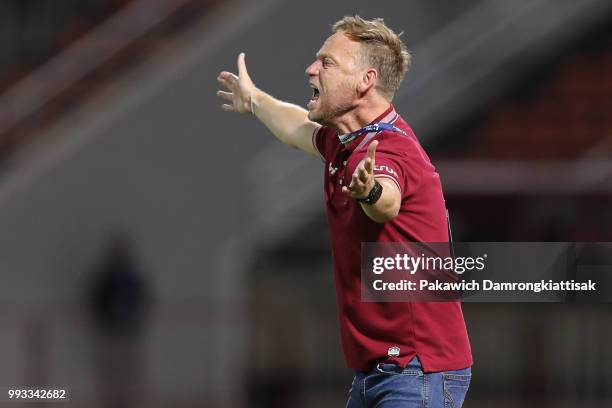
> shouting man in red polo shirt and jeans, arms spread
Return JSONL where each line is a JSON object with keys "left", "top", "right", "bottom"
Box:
{"left": 218, "top": 16, "right": 472, "bottom": 408}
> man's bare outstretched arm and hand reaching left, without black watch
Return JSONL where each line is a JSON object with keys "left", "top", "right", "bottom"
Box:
{"left": 217, "top": 53, "right": 319, "bottom": 156}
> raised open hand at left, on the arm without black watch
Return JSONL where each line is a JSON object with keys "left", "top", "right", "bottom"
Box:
{"left": 217, "top": 52, "right": 257, "bottom": 113}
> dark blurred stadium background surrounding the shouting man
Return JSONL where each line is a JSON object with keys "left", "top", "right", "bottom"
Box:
{"left": 0, "top": 0, "right": 612, "bottom": 408}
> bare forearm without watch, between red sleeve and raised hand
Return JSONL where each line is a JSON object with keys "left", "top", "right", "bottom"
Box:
{"left": 251, "top": 89, "right": 318, "bottom": 153}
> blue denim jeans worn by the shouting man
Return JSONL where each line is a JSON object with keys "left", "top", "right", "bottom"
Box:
{"left": 346, "top": 357, "right": 472, "bottom": 408}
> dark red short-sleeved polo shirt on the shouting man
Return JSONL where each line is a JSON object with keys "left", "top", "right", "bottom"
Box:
{"left": 313, "top": 106, "right": 472, "bottom": 372}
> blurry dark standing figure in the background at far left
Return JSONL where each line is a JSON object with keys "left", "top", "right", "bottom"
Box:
{"left": 90, "top": 232, "right": 151, "bottom": 408}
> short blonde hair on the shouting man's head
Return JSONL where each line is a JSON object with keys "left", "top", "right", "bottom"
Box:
{"left": 332, "top": 15, "right": 412, "bottom": 100}
